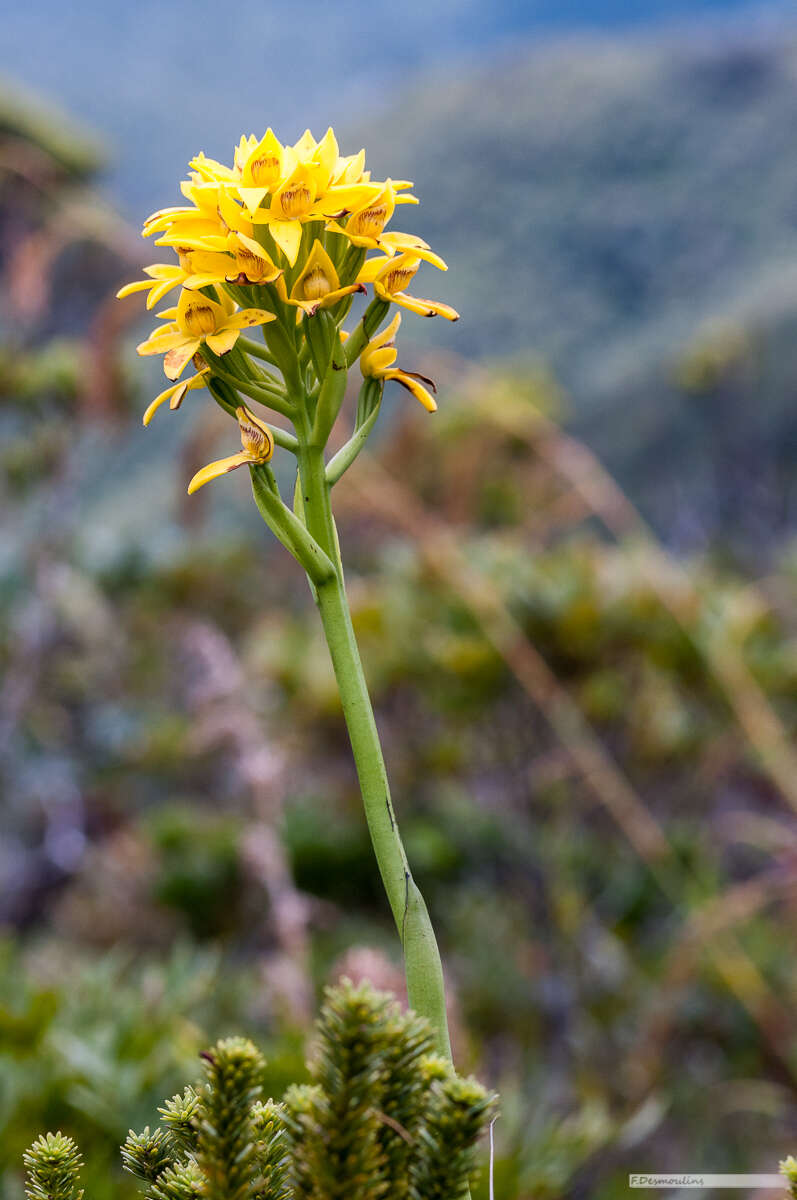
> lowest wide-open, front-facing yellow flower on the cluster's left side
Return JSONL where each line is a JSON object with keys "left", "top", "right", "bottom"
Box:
{"left": 137, "top": 288, "right": 276, "bottom": 379}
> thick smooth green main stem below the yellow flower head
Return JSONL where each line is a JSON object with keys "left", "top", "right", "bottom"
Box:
{"left": 299, "top": 432, "right": 451, "bottom": 1060}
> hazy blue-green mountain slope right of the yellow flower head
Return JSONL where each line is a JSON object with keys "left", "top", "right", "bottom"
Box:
{"left": 353, "top": 22, "right": 797, "bottom": 551}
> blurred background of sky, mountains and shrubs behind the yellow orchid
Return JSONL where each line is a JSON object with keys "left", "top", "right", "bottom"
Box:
{"left": 0, "top": 0, "right": 797, "bottom": 1200}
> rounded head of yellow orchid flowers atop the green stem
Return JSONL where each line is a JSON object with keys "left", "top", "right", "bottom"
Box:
{"left": 118, "top": 128, "right": 457, "bottom": 491}
